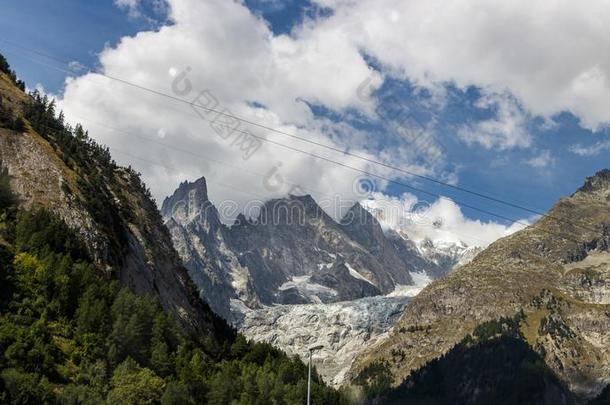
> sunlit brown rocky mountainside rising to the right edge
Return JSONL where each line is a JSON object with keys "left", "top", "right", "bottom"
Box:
{"left": 349, "top": 170, "right": 610, "bottom": 398}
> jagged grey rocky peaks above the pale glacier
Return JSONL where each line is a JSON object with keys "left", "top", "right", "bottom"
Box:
{"left": 161, "top": 178, "right": 476, "bottom": 325}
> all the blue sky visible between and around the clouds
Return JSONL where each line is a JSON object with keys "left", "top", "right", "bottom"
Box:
{"left": 0, "top": 0, "right": 610, "bottom": 237}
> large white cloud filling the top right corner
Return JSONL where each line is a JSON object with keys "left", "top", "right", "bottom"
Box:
{"left": 312, "top": 0, "right": 610, "bottom": 129}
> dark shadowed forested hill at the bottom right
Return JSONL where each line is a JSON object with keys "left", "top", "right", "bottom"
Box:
{"left": 359, "top": 313, "right": 573, "bottom": 405}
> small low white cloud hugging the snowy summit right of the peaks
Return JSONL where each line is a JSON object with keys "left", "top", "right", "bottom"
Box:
{"left": 361, "top": 193, "right": 530, "bottom": 247}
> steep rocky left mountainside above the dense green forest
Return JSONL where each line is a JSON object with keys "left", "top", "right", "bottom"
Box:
{"left": 0, "top": 68, "right": 223, "bottom": 332}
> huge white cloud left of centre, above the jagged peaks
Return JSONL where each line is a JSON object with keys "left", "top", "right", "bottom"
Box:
{"left": 59, "top": 0, "right": 404, "bottom": 218}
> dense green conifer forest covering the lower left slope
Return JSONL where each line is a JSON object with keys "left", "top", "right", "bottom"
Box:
{"left": 0, "top": 204, "right": 342, "bottom": 404}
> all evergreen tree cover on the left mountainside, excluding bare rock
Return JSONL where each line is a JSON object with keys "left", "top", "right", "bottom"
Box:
{"left": 0, "top": 54, "right": 343, "bottom": 404}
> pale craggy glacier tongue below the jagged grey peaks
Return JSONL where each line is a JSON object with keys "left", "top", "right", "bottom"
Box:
{"left": 239, "top": 294, "right": 412, "bottom": 386}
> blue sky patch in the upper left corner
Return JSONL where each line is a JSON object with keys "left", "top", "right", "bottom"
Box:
{"left": 0, "top": 0, "right": 160, "bottom": 92}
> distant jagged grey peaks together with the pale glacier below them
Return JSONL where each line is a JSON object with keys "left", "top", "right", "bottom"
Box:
{"left": 161, "top": 178, "right": 482, "bottom": 385}
